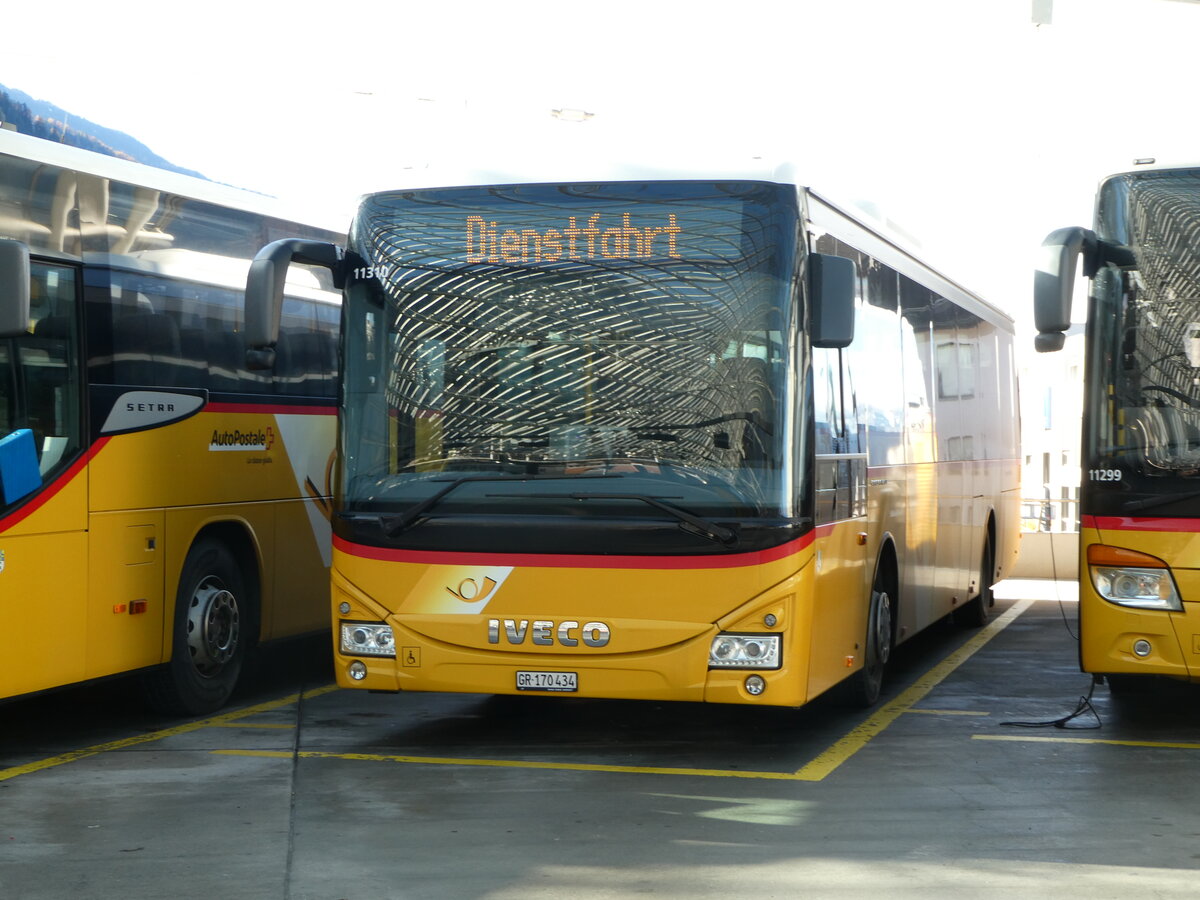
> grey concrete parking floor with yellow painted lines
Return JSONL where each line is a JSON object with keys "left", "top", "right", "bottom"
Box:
{"left": 0, "top": 583, "right": 1200, "bottom": 900}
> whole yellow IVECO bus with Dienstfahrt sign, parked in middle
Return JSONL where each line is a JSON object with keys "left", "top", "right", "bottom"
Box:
{"left": 247, "top": 163, "right": 1019, "bottom": 707}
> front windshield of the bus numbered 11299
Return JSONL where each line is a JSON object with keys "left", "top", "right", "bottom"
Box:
{"left": 1085, "top": 169, "right": 1200, "bottom": 514}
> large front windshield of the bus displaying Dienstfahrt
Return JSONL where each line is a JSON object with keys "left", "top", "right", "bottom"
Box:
{"left": 338, "top": 182, "right": 800, "bottom": 552}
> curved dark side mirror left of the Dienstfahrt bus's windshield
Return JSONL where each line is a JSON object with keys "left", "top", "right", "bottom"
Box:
{"left": 245, "top": 238, "right": 342, "bottom": 370}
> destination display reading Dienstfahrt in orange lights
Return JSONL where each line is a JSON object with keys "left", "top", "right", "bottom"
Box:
{"left": 355, "top": 182, "right": 791, "bottom": 267}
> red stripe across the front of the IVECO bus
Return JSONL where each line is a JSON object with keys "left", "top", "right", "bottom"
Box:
{"left": 334, "top": 532, "right": 815, "bottom": 569}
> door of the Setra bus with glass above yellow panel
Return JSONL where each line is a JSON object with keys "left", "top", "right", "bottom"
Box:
{"left": 0, "top": 260, "right": 88, "bottom": 696}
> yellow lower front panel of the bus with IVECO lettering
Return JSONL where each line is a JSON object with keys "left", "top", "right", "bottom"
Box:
{"left": 332, "top": 522, "right": 902, "bottom": 707}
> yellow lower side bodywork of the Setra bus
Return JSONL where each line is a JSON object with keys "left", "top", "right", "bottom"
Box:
{"left": 0, "top": 404, "right": 335, "bottom": 697}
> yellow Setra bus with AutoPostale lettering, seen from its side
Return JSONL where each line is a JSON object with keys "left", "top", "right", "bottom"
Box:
{"left": 0, "top": 131, "right": 340, "bottom": 714}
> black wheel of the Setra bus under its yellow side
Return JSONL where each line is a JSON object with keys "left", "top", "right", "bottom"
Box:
{"left": 144, "top": 538, "right": 252, "bottom": 715}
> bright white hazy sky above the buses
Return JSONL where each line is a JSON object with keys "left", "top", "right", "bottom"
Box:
{"left": 0, "top": 0, "right": 1200, "bottom": 319}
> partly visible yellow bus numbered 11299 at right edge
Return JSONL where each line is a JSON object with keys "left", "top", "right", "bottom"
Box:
{"left": 1034, "top": 162, "right": 1200, "bottom": 691}
